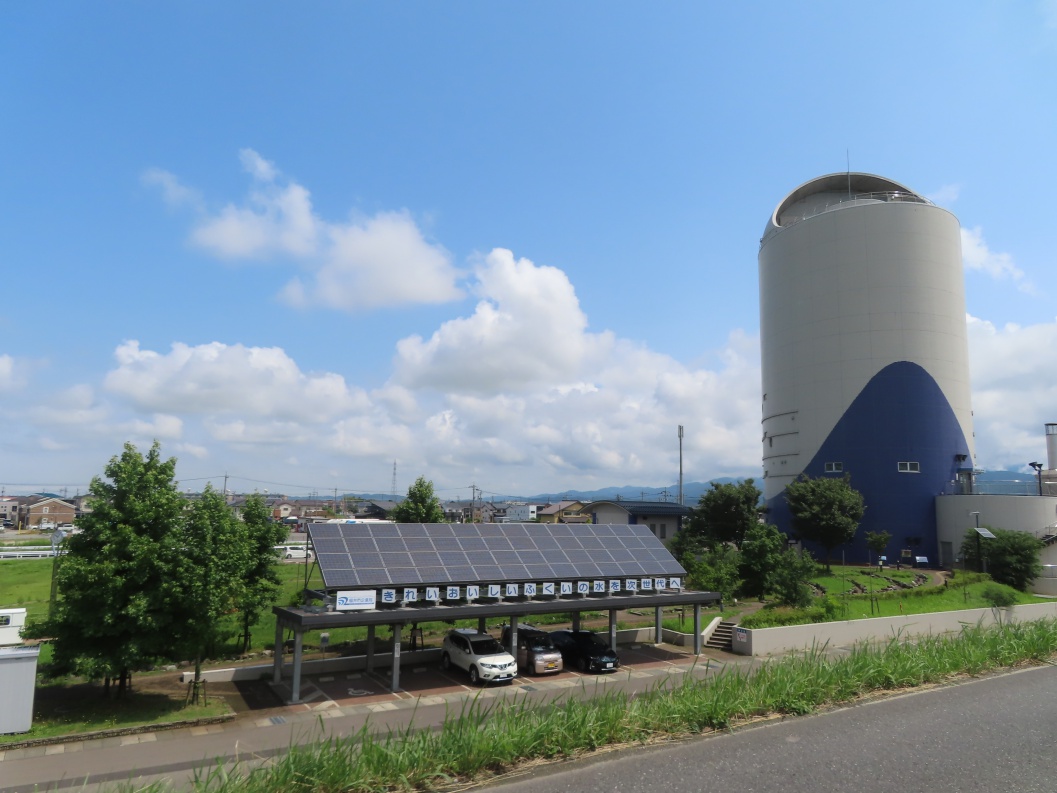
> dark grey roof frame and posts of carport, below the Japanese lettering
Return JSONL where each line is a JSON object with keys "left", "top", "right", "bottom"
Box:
{"left": 272, "top": 592, "right": 723, "bottom": 704}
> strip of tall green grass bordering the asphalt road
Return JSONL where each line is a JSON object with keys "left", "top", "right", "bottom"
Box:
{"left": 127, "top": 620, "right": 1057, "bottom": 793}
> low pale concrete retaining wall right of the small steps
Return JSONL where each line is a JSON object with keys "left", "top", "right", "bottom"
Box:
{"left": 734, "top": 603, "right": 1057, "bottom": 656}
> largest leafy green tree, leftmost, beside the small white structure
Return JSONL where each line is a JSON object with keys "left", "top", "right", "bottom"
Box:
{"left": 24, "top": 442, "right": 186, "bottom": 697}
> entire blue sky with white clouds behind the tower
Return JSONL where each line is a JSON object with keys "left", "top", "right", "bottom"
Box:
{"left": 0, "top": 2, "right": 1057, "bottom": 497}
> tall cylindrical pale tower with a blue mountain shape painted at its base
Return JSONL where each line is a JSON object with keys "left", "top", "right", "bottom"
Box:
{"left": 759, "top": 173, "right": 973, "bottom": 556}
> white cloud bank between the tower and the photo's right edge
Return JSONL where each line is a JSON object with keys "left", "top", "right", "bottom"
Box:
{"left": 968, "top": 316, "right": 1057, "bottom": 471}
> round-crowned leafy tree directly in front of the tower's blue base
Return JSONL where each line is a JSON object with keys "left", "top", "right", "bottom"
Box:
{"left": 785, "top": 474, "right": 866, "bottom": 572}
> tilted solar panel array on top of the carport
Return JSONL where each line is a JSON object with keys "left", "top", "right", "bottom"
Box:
{"left": 309, "top": 523, "right": 686, "bottom": 589}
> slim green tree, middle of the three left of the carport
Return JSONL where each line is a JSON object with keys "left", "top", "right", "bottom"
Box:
{"left": 172, "top": 485, "right": 249, "bottom": 703}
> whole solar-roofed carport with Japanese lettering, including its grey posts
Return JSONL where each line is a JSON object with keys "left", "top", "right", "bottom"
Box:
{"left": 273, "top": 523, "right": 722, "bottom": 703}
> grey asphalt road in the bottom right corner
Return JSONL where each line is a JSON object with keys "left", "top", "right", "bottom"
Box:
{"left": 477, "top": 666, "right": 1057, "bottom": 793}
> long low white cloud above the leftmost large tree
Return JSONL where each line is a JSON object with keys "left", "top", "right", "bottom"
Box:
{"left": 105, "top": 340, "right": 369, "bottom": 425}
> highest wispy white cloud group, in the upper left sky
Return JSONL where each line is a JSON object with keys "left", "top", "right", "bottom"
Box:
{"left": 154, "top": 149, "right": 463, "bottom": 311}
